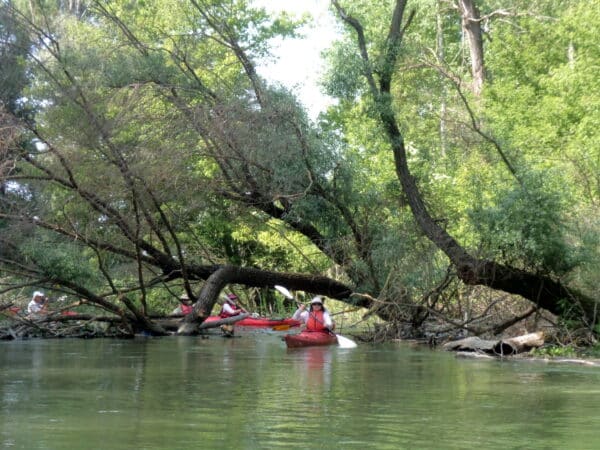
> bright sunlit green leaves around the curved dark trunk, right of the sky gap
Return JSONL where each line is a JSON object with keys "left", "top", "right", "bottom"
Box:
{"left": 326, "top": 0, "right": 600, "bottom": 290}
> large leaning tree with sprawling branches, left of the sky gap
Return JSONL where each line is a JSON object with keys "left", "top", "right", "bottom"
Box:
{"left": 1, "top": 0, "right": 378, "bottom": 333}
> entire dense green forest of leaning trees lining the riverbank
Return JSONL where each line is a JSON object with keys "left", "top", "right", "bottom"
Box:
{"left": 0, "top": 0, "right": 600, "bottom": 342}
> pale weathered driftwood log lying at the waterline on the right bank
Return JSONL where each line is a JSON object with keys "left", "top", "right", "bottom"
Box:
{"left": 443, "top": 331, "right": 544, "bottom": 356}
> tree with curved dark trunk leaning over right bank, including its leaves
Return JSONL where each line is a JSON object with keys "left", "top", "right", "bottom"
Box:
{"left": 333, "top": 1, "right": 596, "bottom": 323}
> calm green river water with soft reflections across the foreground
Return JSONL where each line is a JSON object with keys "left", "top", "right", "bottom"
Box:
{"left": 0, "top": 332, "right": 600, "bottom": 450}
